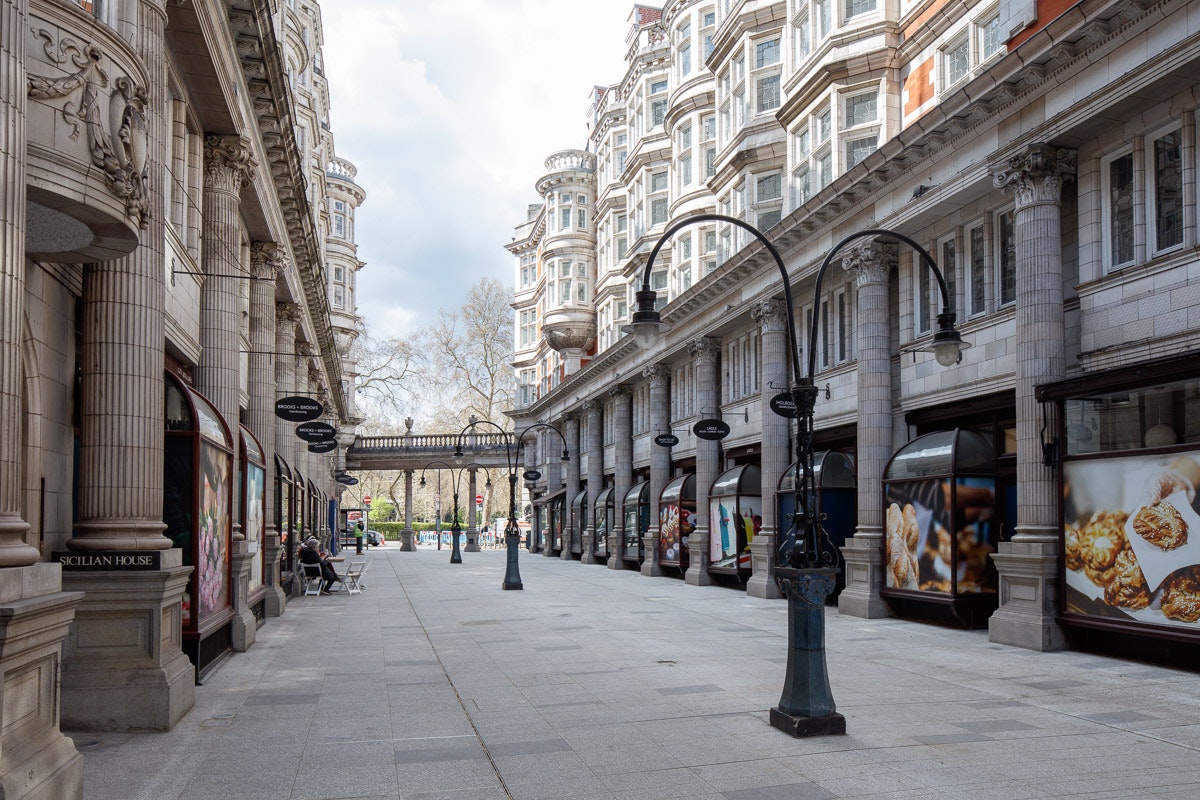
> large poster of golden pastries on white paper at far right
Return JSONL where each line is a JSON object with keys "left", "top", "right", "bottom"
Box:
{"left": 1063, "top": 452, "right": 1200, "bottom": 630}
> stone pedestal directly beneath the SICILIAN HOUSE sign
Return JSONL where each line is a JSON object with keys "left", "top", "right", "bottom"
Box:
{"left": 61, "top": 549, "right": 196, "bottom": 732}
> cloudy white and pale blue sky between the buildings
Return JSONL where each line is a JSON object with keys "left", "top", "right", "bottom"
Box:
{"left": 322, "top": 0, "right": 634, "bottom": 337}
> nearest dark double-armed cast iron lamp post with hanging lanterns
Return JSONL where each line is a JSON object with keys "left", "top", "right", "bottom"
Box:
{"left": 622, "top": 213, "right": 966, "bottom": 736}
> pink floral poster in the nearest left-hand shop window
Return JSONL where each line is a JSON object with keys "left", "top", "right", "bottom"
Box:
{"left": 196, "top": 444, "right": 230, "bottom": 622}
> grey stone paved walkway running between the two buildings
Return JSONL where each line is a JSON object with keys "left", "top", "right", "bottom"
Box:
{"left": 73, "top": 545, "right": 1200, "bottom": 800}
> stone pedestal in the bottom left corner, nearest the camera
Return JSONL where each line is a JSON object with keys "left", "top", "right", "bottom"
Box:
{"left": 0, "top": 564, "right": 83, "bottom": 800}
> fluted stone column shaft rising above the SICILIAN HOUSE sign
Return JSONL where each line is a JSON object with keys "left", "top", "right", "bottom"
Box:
{"left": 67, "top": 0, "right": 170, "bottom": 551}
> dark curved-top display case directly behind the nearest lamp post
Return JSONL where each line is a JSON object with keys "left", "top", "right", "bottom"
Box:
{"left": 775, "top": 450, "right": 858, "bottom": 599}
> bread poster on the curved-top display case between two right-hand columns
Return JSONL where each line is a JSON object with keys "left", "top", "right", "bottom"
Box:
{"left": 883, "top": 477, "right": 998, "bottom": 594}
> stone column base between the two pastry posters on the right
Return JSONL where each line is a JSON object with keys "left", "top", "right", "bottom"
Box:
{"left": 988, "top": 540, "right": 1067, "bottom": 652}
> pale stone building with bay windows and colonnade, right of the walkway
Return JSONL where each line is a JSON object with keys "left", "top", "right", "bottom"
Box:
{"left": 506, "top": 0, "right": 1200, "bottom": 651}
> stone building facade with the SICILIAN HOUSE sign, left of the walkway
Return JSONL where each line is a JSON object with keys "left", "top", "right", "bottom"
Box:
{"left": 0, "top": 0, "right": 365, "bottom": 800}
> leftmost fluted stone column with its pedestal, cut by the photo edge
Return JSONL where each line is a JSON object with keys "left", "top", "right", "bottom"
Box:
{"left": 0, "top": 0, "right": 83, "bottom": 800}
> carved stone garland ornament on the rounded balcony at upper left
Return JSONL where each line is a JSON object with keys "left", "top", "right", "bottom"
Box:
{"left": 26, "top": 30, "right": 150, "bottom": 228}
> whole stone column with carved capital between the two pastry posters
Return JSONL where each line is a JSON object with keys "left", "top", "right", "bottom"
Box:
{"left": 988, "top": 144, "right": 1076, "bottom": 650}
